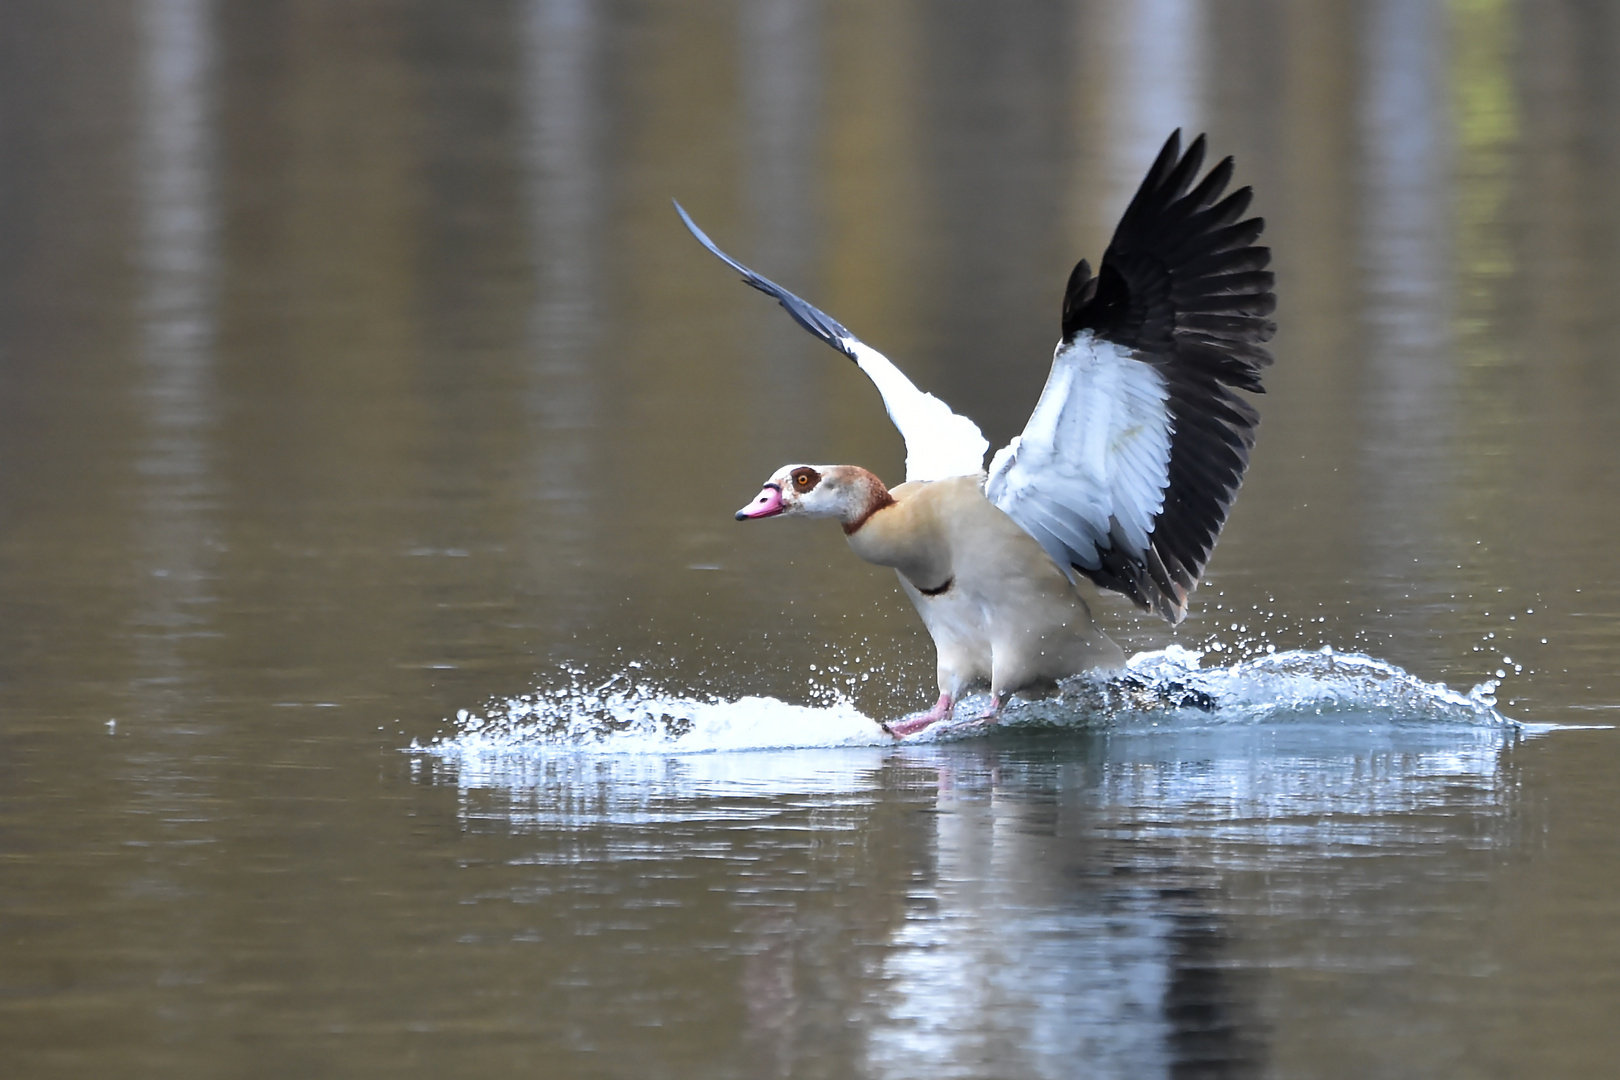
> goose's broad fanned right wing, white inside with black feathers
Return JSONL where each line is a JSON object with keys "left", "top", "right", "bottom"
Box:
{"left": 985, "top": 131, "right": 1277, "bottom": 623}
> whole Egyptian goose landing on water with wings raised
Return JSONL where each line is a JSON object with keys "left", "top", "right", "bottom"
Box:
{"left": 676, "top": 131, "right": 1277, "bottom": 737}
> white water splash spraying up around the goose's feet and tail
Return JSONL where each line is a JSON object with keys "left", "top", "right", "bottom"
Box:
{"left": 408, "top": 646, "right": 1518, "bottom": 763}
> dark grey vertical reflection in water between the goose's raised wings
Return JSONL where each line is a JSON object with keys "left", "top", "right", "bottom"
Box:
{"left": 906, "top": 3, "right": 1072, "bottom": 447}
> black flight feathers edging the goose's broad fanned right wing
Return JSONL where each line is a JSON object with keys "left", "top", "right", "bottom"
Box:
{"left": 1063, "top": 130, "right": 1277, "bottom": 623}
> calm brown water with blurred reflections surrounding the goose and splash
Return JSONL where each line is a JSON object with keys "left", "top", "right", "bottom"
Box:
{"left": 0, "top": 0, "right": 1620, "bottom": 1077}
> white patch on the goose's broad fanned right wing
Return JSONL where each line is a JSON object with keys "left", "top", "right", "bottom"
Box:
{"left": 978, "top": 330, "right": 1173, "bottom": 570}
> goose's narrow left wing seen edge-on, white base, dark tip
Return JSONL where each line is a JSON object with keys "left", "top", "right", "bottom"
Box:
{"left": 676, "top": 202, "right": 990, "bottom": 481}
